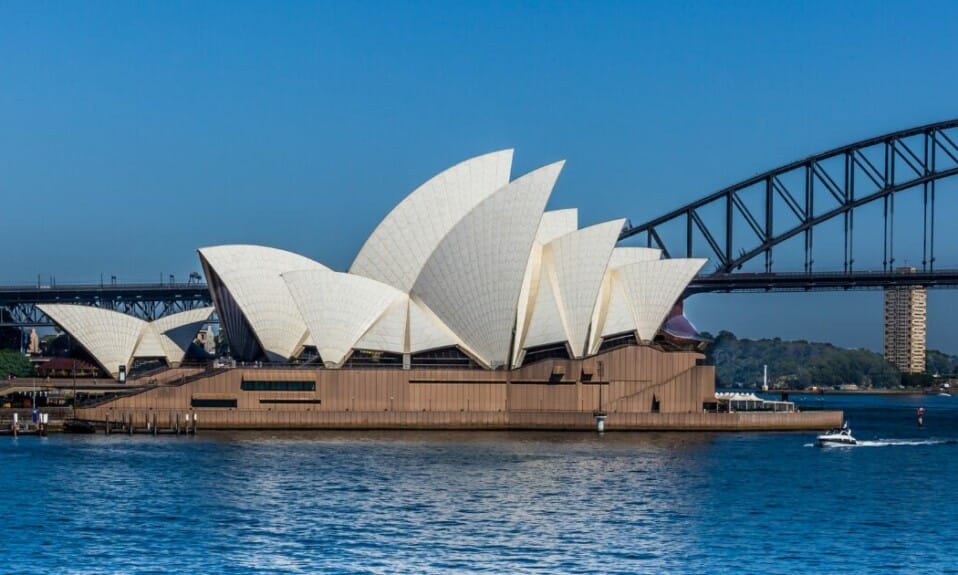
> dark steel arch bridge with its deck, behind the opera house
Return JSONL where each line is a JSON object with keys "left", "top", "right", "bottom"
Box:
{"left": 0, "top": 119, "right": 958, "bottom": 327}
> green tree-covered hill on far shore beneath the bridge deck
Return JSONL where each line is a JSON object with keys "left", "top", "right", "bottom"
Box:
{"left": 703, "top": 331, "right": 958, "bottom": 389}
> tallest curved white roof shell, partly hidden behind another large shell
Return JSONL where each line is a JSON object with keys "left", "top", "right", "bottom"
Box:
{"left": 349, "top": 150, "right": 516, "bottom": 293}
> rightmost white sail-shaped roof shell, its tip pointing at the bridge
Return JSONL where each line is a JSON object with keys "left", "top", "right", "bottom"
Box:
{"left": 617, "top": 258, "right": 708, "bottom": 341}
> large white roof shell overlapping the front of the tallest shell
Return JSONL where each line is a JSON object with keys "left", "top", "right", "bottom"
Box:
{"left": 413, "top": 162, "right": 563, "bottom": 367}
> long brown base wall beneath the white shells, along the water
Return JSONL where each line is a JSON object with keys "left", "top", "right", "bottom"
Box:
{"left": 77, "top": 346, "right": 841, "bottom": 429}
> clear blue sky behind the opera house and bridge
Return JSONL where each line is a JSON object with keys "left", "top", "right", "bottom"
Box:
{"left": 0, "top": 0, "right": 958, "bottom": 352}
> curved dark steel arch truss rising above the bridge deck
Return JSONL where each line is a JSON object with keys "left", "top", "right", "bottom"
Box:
{"left": 620, "top": 120, "right": 958, "bottom": 275}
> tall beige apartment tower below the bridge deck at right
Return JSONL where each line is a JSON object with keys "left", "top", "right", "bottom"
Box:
{"left": 885, "top": 268, "right": 928, "bottom": 373}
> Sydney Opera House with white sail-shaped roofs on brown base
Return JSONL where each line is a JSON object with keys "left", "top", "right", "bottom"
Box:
{"left": 43, "top": 150, "right": 840, "bottom": 429}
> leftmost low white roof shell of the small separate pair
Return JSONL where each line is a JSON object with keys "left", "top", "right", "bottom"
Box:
{"left": 37, "top": 304, "right": 147, "bottom": 377}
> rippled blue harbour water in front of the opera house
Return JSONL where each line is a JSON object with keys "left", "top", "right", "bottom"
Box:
{"left": 0, "top": 395, "right": 958, "bottom": 575}
